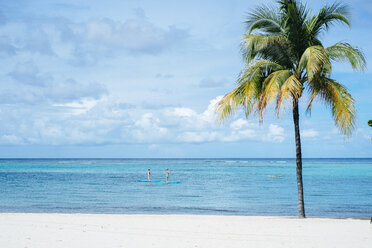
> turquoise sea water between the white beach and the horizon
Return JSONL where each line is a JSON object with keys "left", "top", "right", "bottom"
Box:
{"left": 0, "top": 159, "right": 372, "bottom": 217}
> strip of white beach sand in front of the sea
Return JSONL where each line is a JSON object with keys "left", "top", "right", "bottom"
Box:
{"left": 0, "top": 213, "right": 372, "bottom": 248}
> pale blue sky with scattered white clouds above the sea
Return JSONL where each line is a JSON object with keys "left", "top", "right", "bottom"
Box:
{"left": 0, "top": 0, "right": 372, "bottom": 158}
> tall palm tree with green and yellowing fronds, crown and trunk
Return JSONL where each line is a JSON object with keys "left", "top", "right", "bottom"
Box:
{"left": 217, "top": 0, "right": 366, "bottom": 218}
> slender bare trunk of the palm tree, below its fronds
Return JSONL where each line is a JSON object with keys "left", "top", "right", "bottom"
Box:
{"left": 293, "top": 100, "right": 306, "bottom": 218}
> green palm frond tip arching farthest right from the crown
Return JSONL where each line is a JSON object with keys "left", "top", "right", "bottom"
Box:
{"left": 325, "top": 42, "right": 367, "bottom": 71}
